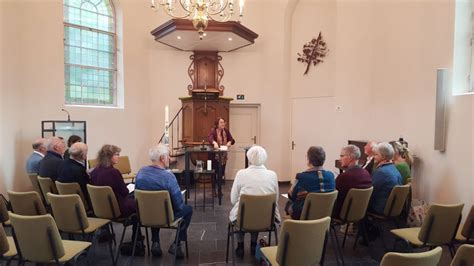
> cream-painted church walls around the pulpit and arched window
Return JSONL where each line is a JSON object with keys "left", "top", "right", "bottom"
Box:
{"left": 0, "top": 0, "right": 474, "bottom": 214}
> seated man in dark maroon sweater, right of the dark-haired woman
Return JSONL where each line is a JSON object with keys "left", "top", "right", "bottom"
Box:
{"left": 333, "top": 145, "right": 372, "bottom": 218}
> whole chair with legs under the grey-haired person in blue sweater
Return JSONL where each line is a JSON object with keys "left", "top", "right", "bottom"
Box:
{"left": 132, "top": 189, "right": 189, "bottom": 265}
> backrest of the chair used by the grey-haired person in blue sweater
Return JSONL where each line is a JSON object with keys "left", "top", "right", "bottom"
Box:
{"left": 135, "top": 189, "right": 174, "bottom": 227}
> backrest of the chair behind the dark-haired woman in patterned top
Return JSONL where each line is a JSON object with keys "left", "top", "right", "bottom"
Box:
{"left": 300, "top": 190, "right": 338, "bottom": 220}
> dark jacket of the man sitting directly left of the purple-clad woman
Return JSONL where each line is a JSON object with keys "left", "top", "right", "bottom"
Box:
{"left": 58, "top": 159, "right": 90, "bottom": 203}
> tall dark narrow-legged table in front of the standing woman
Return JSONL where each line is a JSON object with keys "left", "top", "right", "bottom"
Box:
{"left": 184, "top": 146, "right": 227, "bottom": 205}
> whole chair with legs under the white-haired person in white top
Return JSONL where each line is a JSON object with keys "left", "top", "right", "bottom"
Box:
{"left": 226, "top": 193, "right": 278, "bottom": 264}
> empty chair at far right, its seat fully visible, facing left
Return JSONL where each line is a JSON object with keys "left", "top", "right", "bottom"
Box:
{"left": 391, "top": 204, "right": 464, "bottom": 257}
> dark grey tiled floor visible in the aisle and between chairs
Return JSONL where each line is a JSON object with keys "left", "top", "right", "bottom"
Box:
{"left": 71, "top": 181, "right": 451, "bottom": 265}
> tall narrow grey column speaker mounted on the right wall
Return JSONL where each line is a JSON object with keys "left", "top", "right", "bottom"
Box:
{"left": 434, "top": 68, "right": 448, "bottom": 151}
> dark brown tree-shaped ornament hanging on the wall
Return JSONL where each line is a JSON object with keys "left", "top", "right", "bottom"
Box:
{"left": 298, "top": 32, "right": 329, "bottom": 75}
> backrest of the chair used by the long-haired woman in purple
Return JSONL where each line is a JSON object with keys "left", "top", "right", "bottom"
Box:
{"left": 87, "top": 184, "right": 122, "bottom": 219}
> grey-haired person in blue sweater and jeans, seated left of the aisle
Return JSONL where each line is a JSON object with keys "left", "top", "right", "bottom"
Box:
{"left": 135, "top": 144, "right": 193, "bottom": 258}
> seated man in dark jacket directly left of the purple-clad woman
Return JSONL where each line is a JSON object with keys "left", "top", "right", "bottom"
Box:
{"left": 58, "top": 142, "right": 90, "bottom": 206}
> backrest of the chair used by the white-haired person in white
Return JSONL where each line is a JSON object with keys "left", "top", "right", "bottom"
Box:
{"left": 236, "top": 193, "right": 276, "bottom": 231}
